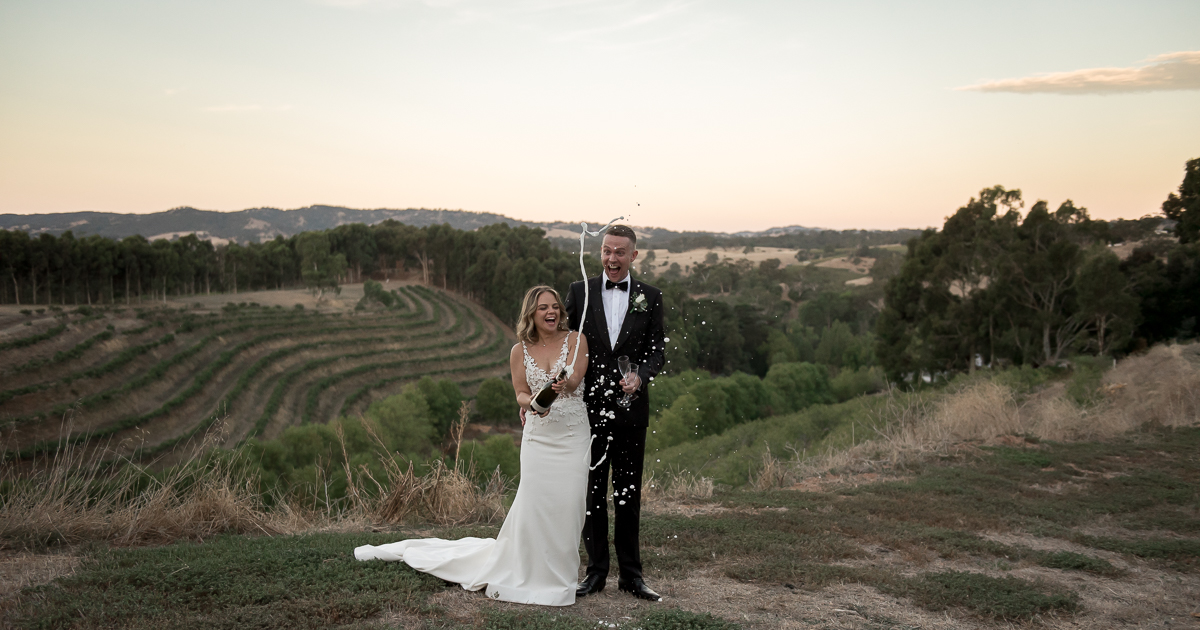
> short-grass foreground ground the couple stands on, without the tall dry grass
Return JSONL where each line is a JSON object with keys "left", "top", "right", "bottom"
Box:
{"left": 4, "top": 427, "right": 1200, "bottom": 629}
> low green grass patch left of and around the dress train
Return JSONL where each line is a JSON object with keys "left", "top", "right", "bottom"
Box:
{"left": 13, "top": 534, "right": 445, "bottom": 630}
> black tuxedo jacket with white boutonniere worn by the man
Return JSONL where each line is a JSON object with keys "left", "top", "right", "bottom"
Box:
{"left": 565, "top": 276, "right": 665, "bottom": 428}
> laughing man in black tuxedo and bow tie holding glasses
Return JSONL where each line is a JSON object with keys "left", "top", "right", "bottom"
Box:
{"left": 564, "top": 226, "right": 664, "bottom": 601}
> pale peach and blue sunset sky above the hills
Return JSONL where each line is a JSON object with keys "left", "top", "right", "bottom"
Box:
{"left": 0, "top": 0, "right": 1200, "bottom": 232}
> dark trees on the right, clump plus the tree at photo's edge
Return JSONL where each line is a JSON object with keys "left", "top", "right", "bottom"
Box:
{"left": 875, "top": 158, "right": 1200, "bottom": 378}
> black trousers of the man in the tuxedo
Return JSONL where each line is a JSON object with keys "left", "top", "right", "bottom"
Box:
{"left": 583, "top": 426, "right": 646, "bottom": 580}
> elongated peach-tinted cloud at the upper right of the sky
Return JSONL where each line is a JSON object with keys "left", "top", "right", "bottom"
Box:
{"left": 955, "top": 50, "right": 1200, "bottom": 95}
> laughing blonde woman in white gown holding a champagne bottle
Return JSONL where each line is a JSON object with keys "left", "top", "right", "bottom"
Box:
{"left": 354, "top": 287, "right": 592, "bottom": 606}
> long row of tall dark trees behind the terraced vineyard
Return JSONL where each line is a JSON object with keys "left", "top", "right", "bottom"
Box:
{"left": 0, "top": 220, "right": 599, "bottom": 322}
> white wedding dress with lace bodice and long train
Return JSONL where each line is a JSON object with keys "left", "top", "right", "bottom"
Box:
{"left": 354, "top": 335, "right": 592, "bottom": 606}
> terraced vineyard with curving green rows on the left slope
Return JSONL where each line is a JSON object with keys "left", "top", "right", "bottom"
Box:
{"left": 0, "top": 284, "right": 514, "bottom": 458}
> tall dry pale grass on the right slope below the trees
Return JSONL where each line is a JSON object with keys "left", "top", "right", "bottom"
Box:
{"left": 796, "top": 343, "right": 1200, "bottom": 477}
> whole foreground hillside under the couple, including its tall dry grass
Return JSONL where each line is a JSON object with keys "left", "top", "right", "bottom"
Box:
{"left": 0, "top": 346, "right": 1200, "bottom": 630}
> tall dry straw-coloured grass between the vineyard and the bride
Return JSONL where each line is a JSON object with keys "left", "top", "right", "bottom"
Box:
{"left": 0, "top": 406, "right": 511, "bottom": 550}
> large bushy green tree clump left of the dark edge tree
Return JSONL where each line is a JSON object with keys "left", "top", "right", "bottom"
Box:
{"left": 873, "top": 186, "right": 1112, "bottom": 379}
